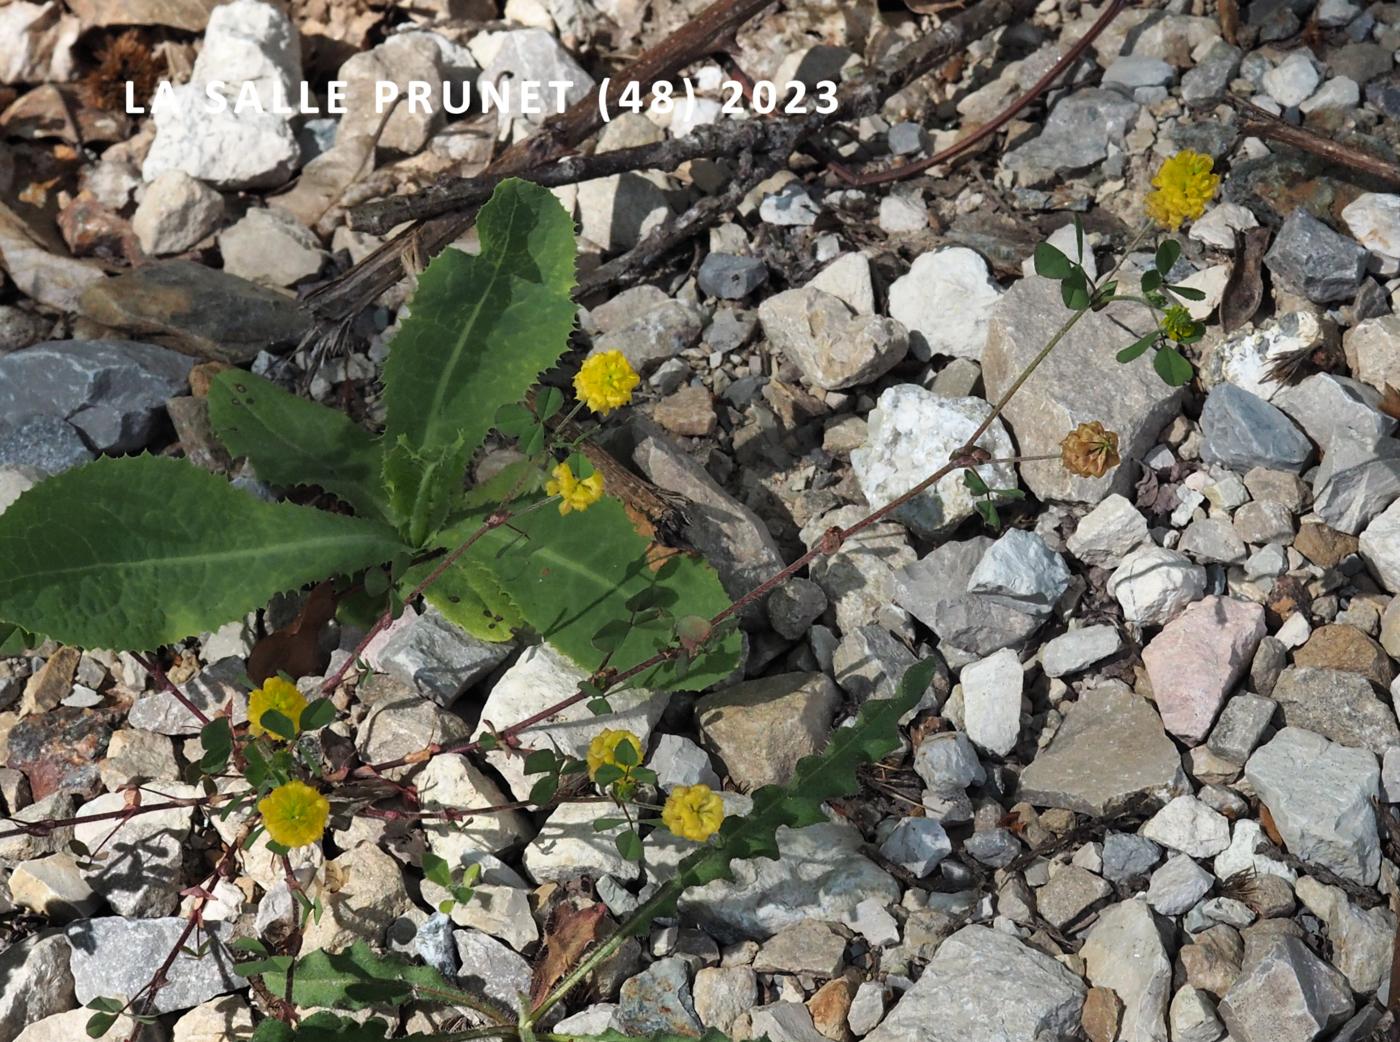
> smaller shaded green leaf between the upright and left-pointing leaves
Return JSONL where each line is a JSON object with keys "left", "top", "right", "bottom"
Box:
{"left": 209, "top": 370, "right": 389, "bottom": 520}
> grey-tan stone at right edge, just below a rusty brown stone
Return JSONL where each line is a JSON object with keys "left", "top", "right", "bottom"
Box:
{"left": 1274, "top": 665, "right": 1400, "bottom": 756}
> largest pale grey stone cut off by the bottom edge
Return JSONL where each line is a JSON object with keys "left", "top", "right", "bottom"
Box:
{"left": 867, "top": 926, "right": 1085, "bottom": 1042}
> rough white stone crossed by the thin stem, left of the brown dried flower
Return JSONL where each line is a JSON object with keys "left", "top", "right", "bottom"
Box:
{"left": 851, "top": 384, "right": 1029, "bottom": 538}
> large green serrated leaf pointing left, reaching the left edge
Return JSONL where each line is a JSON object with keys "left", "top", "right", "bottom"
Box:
{"left": 0, "top": 455, "right": 406, "bottom": 650}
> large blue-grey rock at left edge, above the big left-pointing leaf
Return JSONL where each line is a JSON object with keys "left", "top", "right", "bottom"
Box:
{"left": 0, "top": 340, "right": 193, "bottom": 452}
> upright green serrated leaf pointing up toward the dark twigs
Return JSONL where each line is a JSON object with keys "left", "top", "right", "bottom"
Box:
{"left": 384, "top": 178, "right": 575, "bottom": 467}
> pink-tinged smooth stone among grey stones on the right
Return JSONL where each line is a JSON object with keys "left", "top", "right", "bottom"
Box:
{"left": 1142, "top": 597, "right": 1264, "bottom": 744}
